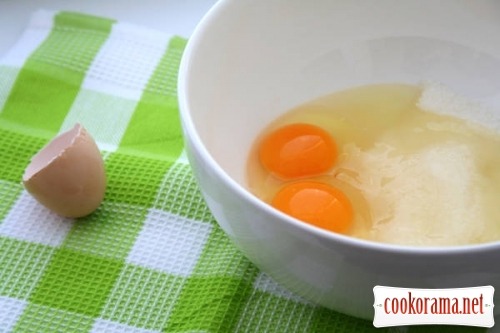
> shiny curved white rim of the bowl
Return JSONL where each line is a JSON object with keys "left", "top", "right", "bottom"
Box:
{"left": 177, "top": 0, "right": 500, "bottom": 256}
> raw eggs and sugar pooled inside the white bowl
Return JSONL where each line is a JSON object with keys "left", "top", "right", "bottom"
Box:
{"left": 247, "top": 82, "right": 500, "bottom": 246}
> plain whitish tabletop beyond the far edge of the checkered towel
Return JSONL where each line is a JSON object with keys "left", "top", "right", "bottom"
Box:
{"left": 0, "top": 0, "right": 216, "bottom": 56}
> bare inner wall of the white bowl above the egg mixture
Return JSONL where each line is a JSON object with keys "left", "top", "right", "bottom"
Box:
{"left": 185, "top": 0, "right": 500, "bottom": 192}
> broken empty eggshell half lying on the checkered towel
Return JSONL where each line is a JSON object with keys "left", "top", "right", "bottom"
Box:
{"left": 23, "top": 124, "right": 106, "bottom": 218}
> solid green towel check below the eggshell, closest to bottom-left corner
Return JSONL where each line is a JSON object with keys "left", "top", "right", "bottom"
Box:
{"left": 30, "top": 249, "right": 123, "bottom": 317}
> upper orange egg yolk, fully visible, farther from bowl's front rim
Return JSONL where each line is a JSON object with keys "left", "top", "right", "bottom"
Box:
{"left": 259, "top": 123, "right": 337, "bottom": 179}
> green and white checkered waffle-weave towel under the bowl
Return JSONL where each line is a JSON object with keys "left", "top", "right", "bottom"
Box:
{"left": 0, "top": 11, "right": 486, "bottom": 333}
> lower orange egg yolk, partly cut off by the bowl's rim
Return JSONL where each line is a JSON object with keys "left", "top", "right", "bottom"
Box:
{"left": 271, "top": 181, "right": 353, "bottom": 233}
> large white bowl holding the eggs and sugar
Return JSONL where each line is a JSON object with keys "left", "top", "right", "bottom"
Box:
{"left": 178, "top": 0, "right": 500, "bottom": 319}
